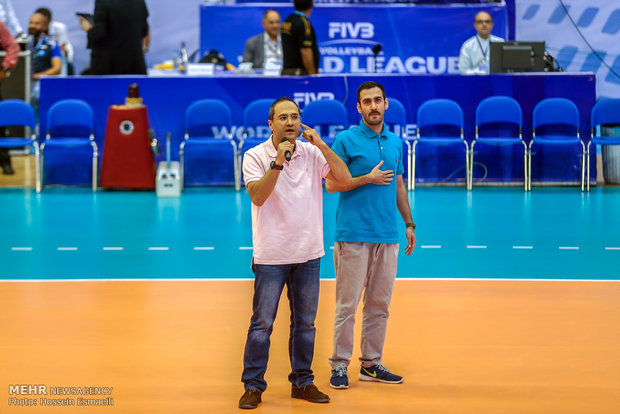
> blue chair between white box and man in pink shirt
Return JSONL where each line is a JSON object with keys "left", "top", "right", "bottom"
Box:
{"left": 179, "top": 99, "right": 240, "bottom": 190}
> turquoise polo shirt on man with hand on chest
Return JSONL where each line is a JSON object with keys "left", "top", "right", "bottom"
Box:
{"left": 332, "top": 120, "right": 404, "bottom": 243}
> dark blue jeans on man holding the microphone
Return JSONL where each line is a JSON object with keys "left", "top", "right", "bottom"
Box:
{"left": 241, "top": 259, "right": 321, "bottom": 393}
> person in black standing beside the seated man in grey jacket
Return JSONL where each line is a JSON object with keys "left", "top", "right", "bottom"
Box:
{"left": 282, "top": 0, "right": 320, "bottom": 75}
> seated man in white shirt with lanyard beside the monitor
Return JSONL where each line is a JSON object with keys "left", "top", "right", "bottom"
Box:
{"left": 459, "top": 11, "right": 504, "bottom": 75}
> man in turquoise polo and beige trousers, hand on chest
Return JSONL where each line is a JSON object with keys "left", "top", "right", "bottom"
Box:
{"left": 326, "top": 81, "right": 416, "bottom": 389}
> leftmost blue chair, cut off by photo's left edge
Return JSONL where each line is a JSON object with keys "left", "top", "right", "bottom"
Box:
{"left": 0, "top": 99, "right": 41, "bottom": 193}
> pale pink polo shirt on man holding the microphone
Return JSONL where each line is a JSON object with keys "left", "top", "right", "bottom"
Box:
{"left": 243, "top": 137, "right": 330, "bottom": 264}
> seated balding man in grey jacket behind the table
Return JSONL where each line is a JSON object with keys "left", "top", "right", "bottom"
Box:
{"left": 242, "top": 9, "right": 282, "bottom": 69}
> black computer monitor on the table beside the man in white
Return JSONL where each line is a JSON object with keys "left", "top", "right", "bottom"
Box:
{"left": 489, "top": 41, "right": 545, "bottom": 73}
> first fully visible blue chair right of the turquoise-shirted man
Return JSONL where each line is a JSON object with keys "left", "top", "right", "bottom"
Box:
{"left": 411, "top": 99, "right": 471, "bottom": 190}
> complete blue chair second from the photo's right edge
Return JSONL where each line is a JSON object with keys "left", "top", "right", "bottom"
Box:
{"left": 528, "top": 98, "right": 586, "bottom": 191}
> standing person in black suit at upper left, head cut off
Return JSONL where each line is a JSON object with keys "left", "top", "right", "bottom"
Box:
{"left": 80, "top": 0, "right": 149, "bottom": 75}
